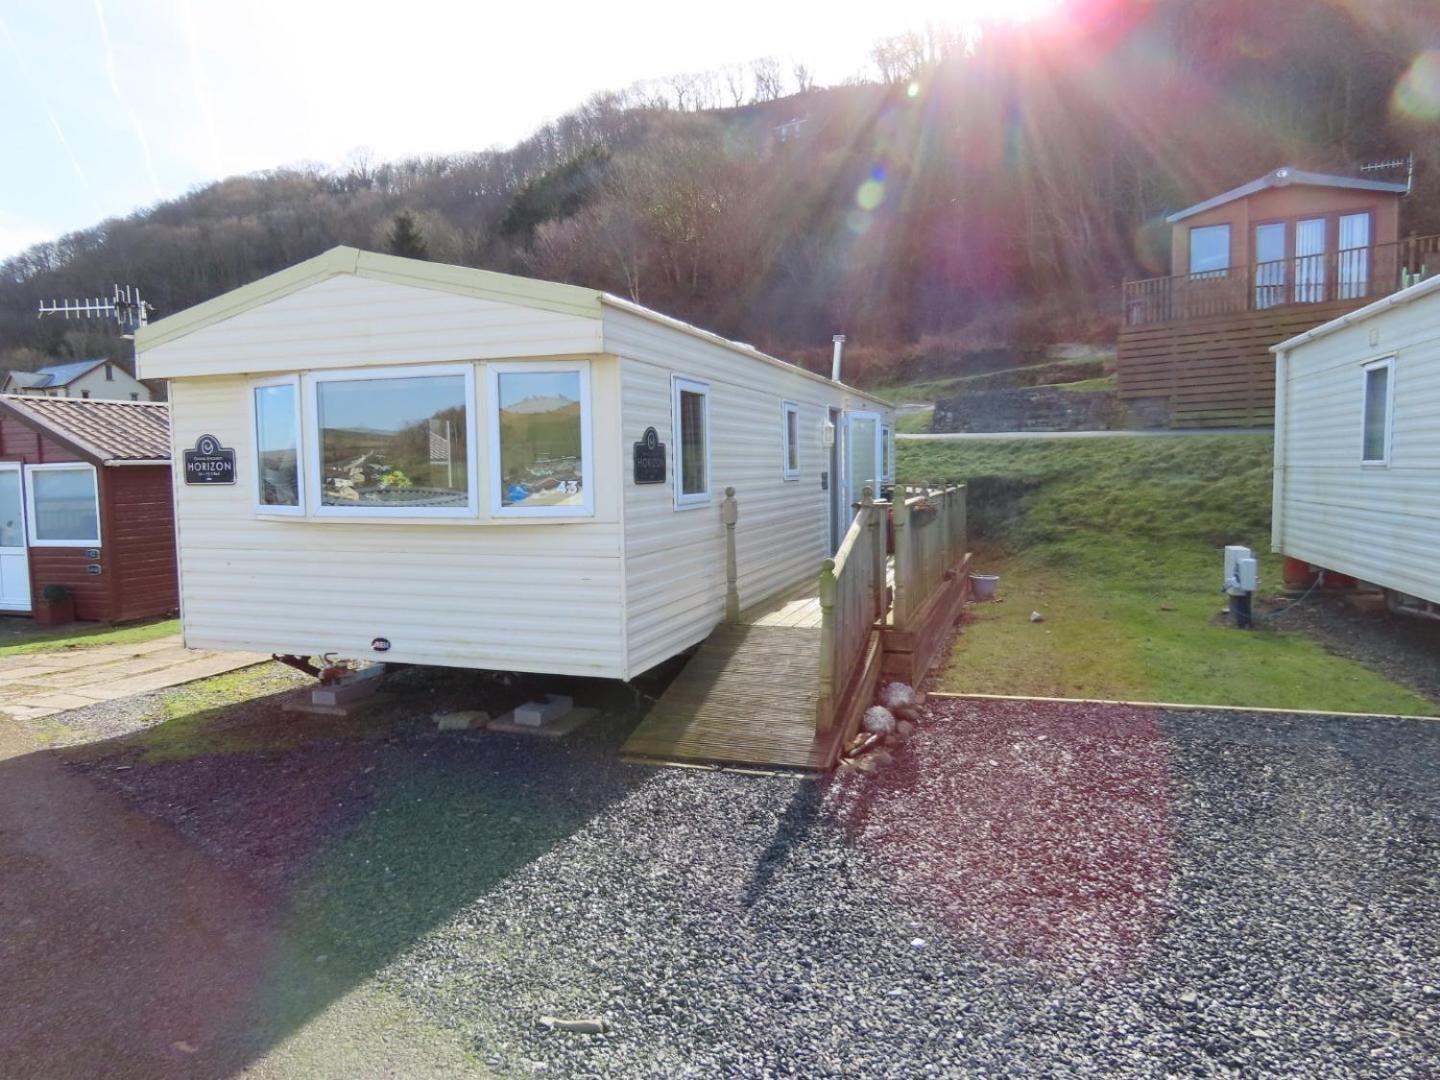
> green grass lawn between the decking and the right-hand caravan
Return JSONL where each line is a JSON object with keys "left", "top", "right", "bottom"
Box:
{"left": 897, "top": 435, "right": 1440, "bottom": 716}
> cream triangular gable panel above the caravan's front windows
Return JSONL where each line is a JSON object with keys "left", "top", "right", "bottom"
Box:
{"left": 140, "top": 274, "right": 600, "bottom": 379}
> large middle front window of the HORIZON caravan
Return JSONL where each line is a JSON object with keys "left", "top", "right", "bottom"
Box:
{"left": 311, "top": 366, "right": 475, "bottom": 517}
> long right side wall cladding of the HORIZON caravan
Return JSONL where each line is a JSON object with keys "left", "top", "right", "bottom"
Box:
{"left": 605, "top": 307, "right": 891, "bottom": 674}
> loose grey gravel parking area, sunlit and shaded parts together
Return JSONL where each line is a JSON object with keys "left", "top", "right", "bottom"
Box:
{"left": 14, "top": 688, "right": 1440, "bottom": 1077}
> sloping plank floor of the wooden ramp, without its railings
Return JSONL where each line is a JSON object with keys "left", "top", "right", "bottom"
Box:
{"left": 625, "top": 622, "right": 837, "bottom": 769}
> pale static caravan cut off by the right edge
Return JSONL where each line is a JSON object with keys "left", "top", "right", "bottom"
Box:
{"left": 1272, "top": 278, "right": 1440, "bottom": 608}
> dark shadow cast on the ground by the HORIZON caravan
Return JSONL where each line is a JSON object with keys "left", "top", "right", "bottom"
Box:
{"left": 0, "top": 676, "right": 652, "bottom": 1077}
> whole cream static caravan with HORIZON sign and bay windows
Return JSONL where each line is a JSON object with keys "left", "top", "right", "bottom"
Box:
{"left": 135, "top": 248, "right": 894, "bottom": 678}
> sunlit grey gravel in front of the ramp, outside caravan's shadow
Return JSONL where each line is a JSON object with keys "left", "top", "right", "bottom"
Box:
{"left": 382, "top": 698, "right": 1440, "bottom": 1077}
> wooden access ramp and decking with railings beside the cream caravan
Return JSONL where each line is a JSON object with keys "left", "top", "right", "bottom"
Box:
{"left": 624, "top": 485, "right": 966, "bottom": 769}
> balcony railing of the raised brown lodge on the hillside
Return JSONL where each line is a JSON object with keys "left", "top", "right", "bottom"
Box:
{"left": 1122, "top": 236, "right": 1440, "bottom": 327}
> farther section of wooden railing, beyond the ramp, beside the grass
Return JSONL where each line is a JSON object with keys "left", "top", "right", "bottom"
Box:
{"left": 891, "top": 484, "right": 966, "bottom": 629}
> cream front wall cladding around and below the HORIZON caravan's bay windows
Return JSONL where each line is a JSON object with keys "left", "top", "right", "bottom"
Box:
{"left": 170, "top": 371, "right": 625, "bottom": 677}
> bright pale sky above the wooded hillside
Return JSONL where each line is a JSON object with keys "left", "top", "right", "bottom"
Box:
{"left": 0, "top": 0, "right": 1054, "bottom": 259}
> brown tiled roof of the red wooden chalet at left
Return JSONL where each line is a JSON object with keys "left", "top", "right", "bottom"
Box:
{"left": 0, "top": 395, "right": 170, "bottom": 462}
